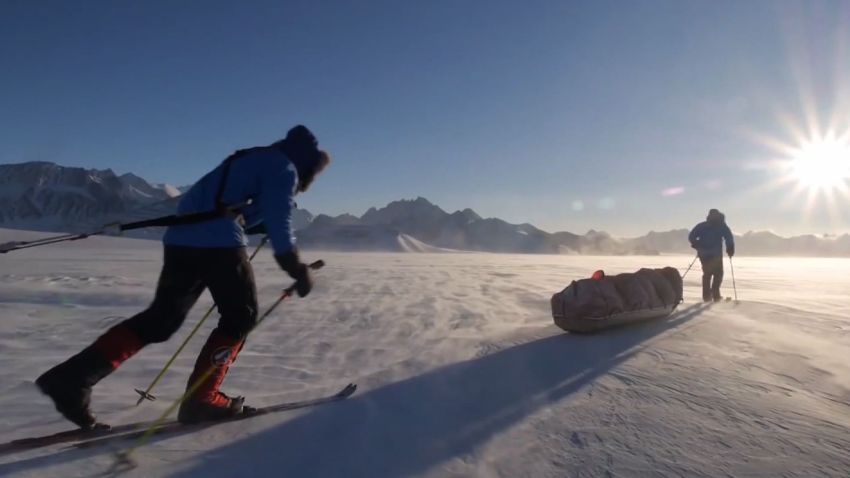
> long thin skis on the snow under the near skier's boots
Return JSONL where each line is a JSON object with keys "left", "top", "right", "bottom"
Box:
{"left": 0, "top": 383, "right": 357, "bottom": 456}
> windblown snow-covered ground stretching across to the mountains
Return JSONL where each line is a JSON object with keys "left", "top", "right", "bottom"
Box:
{"left": 0, "top": 231, "right": 850, "bottom": 477}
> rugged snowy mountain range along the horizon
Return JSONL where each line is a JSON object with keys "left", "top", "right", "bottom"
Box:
{"left": 0, "top": 162, "right": 850, "bottom": 256}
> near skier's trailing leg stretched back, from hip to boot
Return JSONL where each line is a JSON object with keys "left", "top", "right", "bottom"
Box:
{"left": 36, "top": 247, "right": 204, "bottom": 428}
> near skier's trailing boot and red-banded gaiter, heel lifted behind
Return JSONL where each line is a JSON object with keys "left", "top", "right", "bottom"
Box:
{"left": 35, "top": 324, "right": 144, "bottom": 429}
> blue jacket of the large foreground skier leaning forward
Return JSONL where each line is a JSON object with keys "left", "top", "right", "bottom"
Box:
{"left": 162, "top": 146, "right": 298, "bottom": 254}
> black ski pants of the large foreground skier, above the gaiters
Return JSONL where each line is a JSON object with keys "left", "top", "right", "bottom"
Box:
{"left": 123, "top": 246, "right": 257, "bottom": 344}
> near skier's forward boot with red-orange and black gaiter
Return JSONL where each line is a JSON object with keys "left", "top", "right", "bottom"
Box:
{"left": 177, "top": 329, "right": 245, "bottom": 423}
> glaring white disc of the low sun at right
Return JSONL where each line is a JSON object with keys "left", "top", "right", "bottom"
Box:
{"left": 788, "top": 137, "right": 850, "bottom": 193}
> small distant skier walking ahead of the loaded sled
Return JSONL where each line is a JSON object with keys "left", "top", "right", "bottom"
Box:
{"left": 688, "top": 209, "right": 735, "bottom": 302}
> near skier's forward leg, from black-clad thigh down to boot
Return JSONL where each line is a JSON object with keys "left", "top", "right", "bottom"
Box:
{"left": 177, "top": 248, "right": 257, "bottom": 423}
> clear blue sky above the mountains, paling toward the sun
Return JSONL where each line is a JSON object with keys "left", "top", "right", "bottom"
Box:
{"left": 0, "top": 0, "right": 850, "bottom": 235}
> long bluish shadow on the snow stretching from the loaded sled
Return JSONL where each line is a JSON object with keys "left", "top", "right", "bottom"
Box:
{"left": 0, "top": 304, "right": 705, "bottom": 478}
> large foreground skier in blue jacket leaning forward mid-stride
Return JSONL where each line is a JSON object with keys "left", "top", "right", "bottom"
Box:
{"left": 36, "top": 125, "right": 330, "bottom": 428}
